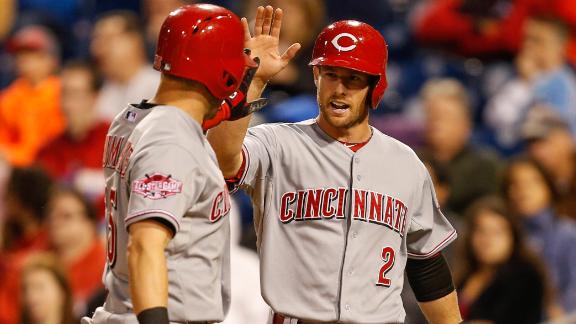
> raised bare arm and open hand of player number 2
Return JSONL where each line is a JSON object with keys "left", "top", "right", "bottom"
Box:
{"left": 207, "top": 6, "right": 300, "bottom": 177}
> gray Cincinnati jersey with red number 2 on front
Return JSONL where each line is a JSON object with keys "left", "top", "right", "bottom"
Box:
{"left": 240, "top": 120, "right": 456, "bottom": 323}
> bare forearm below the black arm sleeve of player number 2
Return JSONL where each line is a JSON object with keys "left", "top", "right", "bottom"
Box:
{"left": 418, "top": 291, "right": 462, "bottom": 324}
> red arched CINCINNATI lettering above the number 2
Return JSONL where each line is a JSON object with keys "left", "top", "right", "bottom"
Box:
{"left": 279, "top": 188, "right": 408, "bottom": 236}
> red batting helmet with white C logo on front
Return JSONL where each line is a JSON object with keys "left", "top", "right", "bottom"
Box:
{"left": 309, "top": 20, "right": 388, "bottom": 108}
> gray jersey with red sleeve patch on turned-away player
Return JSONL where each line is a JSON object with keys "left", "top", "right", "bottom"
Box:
{"left": 93, "top": 106, "right": 230, "bottom": 323}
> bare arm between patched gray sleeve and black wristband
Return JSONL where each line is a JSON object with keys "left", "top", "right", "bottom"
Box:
{"left": 128, "top": 220, "right": 172, "bottom": 314}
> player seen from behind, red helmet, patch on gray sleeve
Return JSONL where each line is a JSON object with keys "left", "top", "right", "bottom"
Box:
{"left": 83, "top": 4, "right": 270, "bottom": 324}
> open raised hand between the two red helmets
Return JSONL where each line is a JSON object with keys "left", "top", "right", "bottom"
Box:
{"left": 242, "top": 6, "right": 300, "bottom": 84}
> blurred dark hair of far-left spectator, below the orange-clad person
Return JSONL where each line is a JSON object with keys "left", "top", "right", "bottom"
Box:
{"left": 6, "top": 167, "right": 53, "bottom": 221}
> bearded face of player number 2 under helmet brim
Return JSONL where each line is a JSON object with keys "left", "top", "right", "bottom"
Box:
{"left": 314, "top": 66, "right": 371, "bottom": 129}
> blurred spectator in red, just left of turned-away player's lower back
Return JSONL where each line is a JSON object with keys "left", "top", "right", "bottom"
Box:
{"left": 46, "top": 188, "right": 106, "bottom": 317}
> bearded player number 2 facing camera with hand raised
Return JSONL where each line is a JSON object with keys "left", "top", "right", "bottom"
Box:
{"left": 208, "top": 8, "right": 461, "bottom": 324}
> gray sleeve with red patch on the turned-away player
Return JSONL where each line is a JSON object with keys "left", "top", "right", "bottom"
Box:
{"left": 125, "top": 144, "right": 203, "bottom": 234}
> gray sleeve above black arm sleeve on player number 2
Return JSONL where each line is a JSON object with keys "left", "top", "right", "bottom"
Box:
{"left": 406, "top": 166, "right": 456, "bottom": 259}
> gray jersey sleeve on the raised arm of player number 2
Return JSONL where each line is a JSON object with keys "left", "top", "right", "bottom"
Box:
{"left": 240, "top": 125, "right": 277, "bottom": 189}
